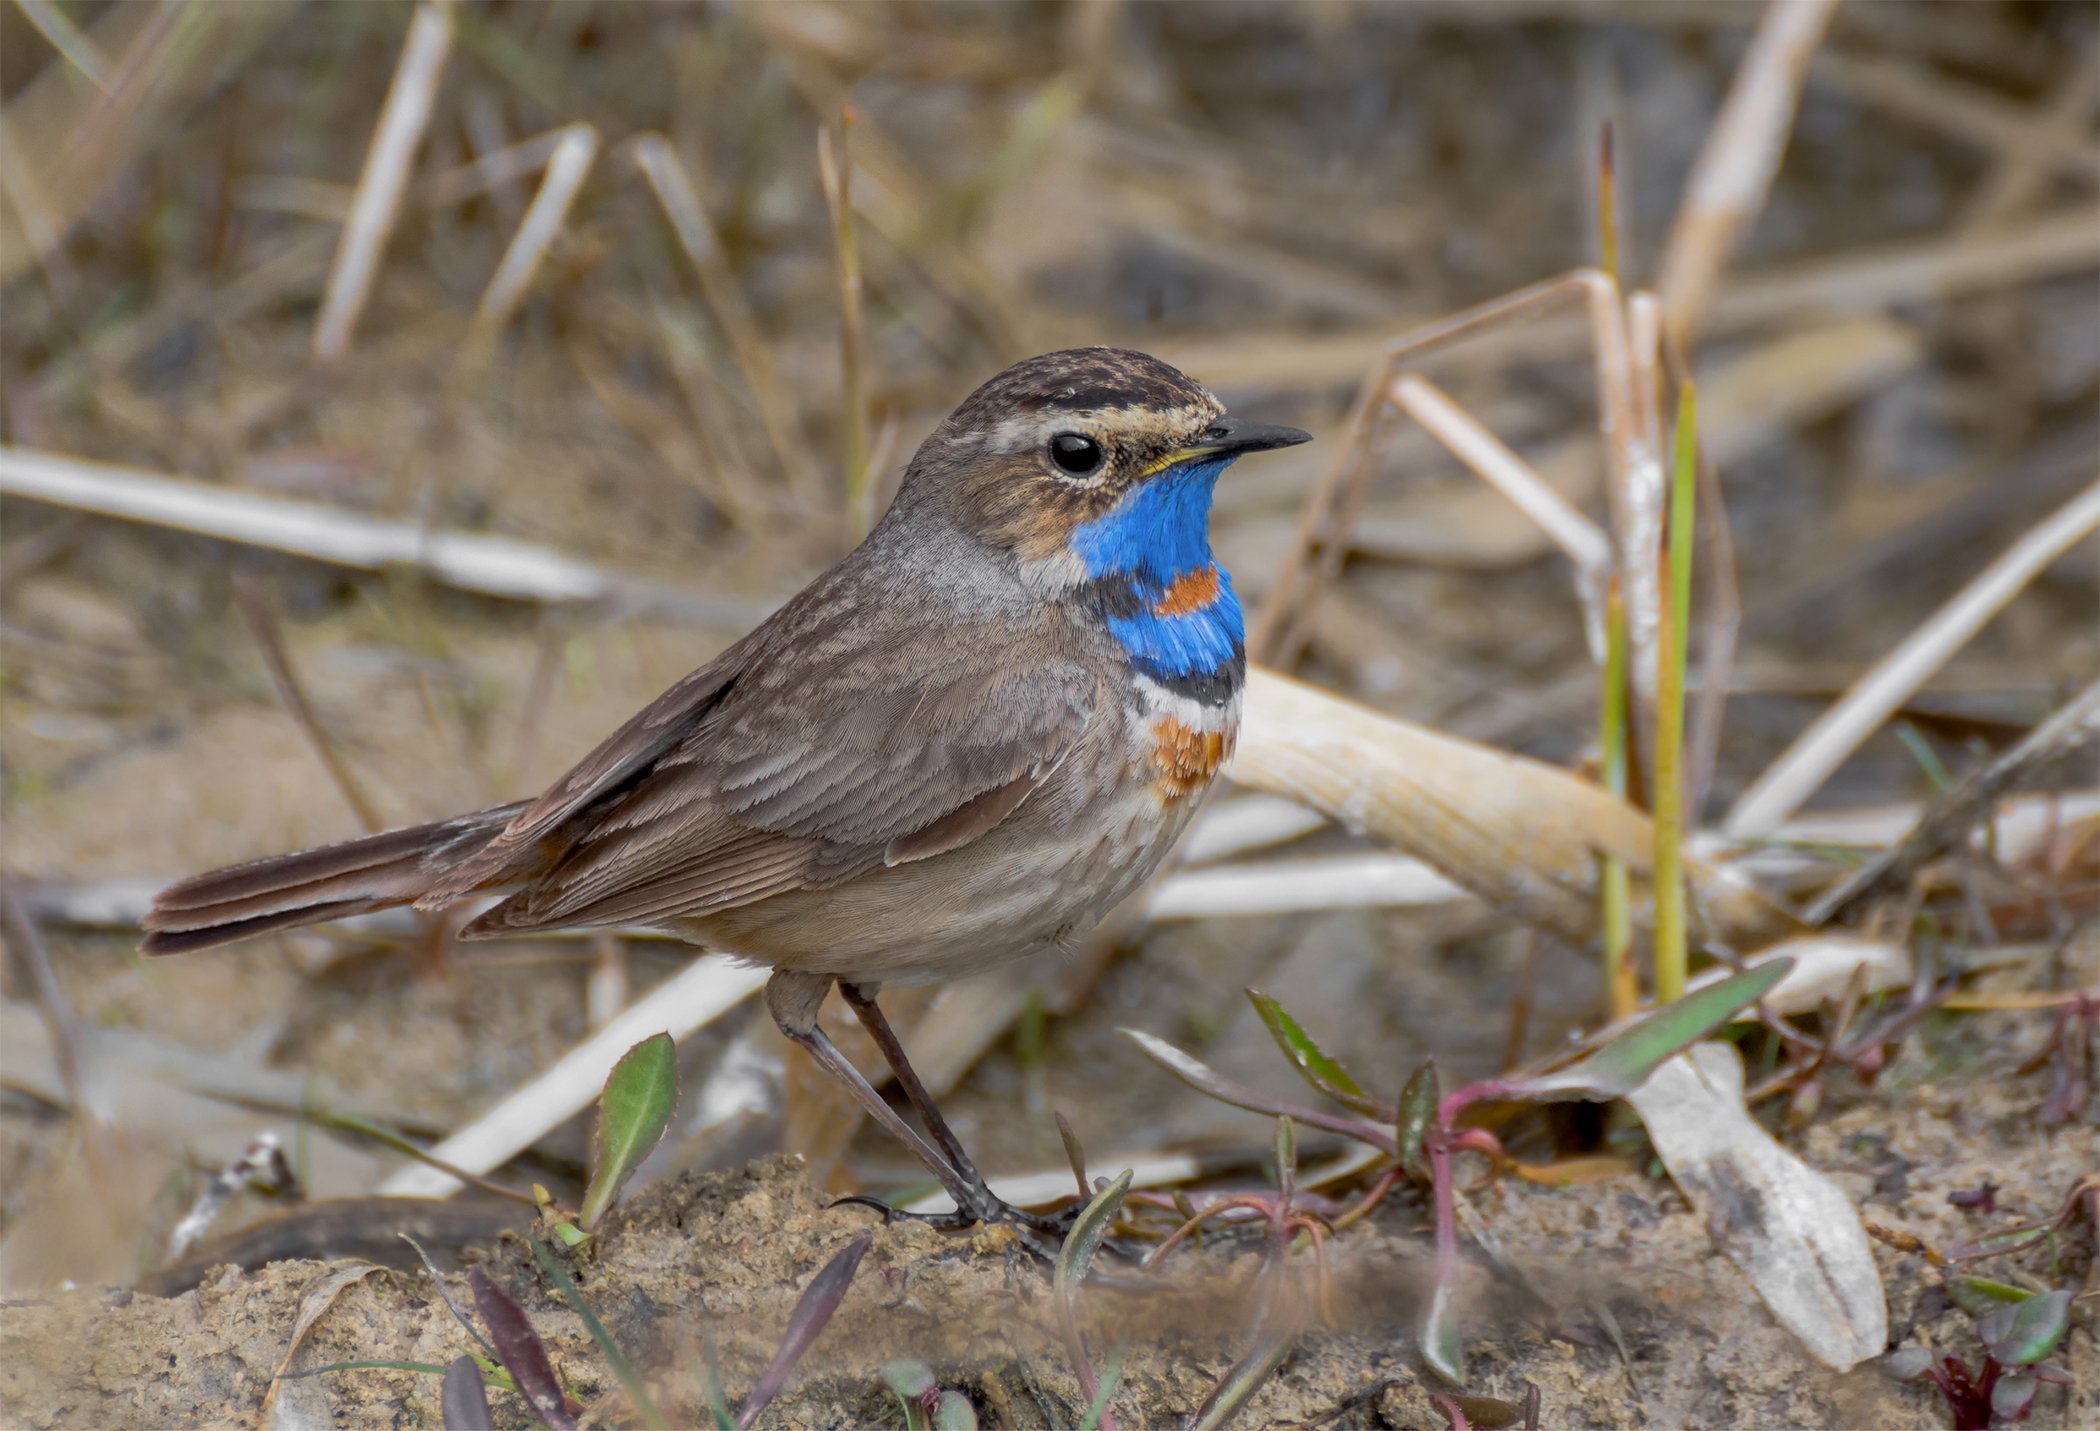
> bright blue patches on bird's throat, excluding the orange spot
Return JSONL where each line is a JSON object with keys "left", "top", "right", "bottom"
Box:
{"left": 1071, "top": 454, "right": 1245, "bottom": 683}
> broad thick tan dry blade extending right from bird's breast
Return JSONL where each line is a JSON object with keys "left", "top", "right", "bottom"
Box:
{"left": 1229, "top": 668, "right": 1791, "bottom": 948}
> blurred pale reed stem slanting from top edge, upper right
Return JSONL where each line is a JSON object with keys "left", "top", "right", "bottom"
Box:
{"left": 1657, "top": 0, "right": 1838, "bottom": 349}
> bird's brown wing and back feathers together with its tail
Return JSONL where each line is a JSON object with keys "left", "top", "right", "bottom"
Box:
{"left": 145, "top": 588, "right": 1096, "bottom": 954}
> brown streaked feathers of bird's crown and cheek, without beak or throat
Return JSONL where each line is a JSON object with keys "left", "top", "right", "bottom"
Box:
{"left": 897, "top": 347, "right": 1224, "bottom": 557}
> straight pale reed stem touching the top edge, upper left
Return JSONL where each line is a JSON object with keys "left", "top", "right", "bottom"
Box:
{"left": 313, "top": 4, "right": 452, "bottom": 361}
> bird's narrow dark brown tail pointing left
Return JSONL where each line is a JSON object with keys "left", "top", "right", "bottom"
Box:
{"left": 139, "top": 801, "right": 527, "bottom": 954}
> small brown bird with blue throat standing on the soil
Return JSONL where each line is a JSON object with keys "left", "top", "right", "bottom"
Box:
{"left": 143, "top": 349, "right": 1310, "bottom": 1229}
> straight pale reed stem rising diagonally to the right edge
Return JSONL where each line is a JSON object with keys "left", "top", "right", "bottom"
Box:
{"left": 1722, "top": 483, "right": 2100, "bottom": 838}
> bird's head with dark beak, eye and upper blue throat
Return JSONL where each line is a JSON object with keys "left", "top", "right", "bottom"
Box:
{"left": 899, "top": 349, "right": 1310, "bottom": 586}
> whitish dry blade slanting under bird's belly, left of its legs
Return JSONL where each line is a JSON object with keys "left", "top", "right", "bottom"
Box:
{"left": 380, "top": 954, "right": 767, "bottom": 1198}
